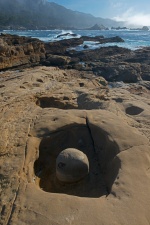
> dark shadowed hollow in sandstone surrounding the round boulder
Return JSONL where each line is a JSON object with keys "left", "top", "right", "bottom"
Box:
{"left": 34, "top": 122, "right": 121, "bottom": 198}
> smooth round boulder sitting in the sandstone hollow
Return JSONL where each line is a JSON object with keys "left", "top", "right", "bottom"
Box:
{"left": 56, "top": 148, "right": 89, "bottom": 183}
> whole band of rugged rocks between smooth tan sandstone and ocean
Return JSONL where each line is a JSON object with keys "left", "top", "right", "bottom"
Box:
{"left": 0, "top": 34, "right": 150, "bottom": 83}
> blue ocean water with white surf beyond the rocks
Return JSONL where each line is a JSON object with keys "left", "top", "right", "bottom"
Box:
{"left": 2, "top": 30, "right": 150, "bottom": 51}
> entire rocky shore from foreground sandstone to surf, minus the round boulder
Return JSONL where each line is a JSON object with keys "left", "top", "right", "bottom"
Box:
{"left": 0, "top": 34, "right": 150, "bottom": 225}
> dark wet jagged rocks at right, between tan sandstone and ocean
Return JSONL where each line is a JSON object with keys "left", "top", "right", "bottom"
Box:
{"left": 68, "top": 46, "right": 150, "bottom": 83}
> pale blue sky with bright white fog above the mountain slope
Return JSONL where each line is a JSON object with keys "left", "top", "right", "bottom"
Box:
{"left": 49, "top": 0, "right": 150, "bottom": 26}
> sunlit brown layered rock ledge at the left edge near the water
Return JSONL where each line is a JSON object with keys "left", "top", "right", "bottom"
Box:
{"left": 0, "top": 34, "right": 45, "bottom": 69}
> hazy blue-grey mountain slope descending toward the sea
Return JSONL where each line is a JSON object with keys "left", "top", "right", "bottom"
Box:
{"left": 0, "top": 0, "right": 122, "bottom": 30}
